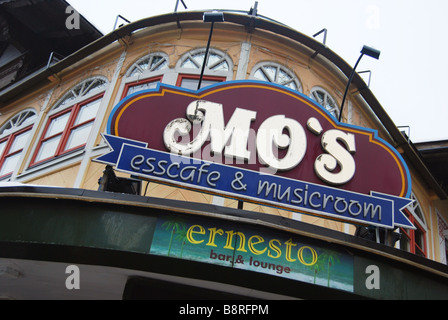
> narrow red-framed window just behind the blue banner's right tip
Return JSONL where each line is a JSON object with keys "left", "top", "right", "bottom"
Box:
{"left": 400, "top": 194, "right": 427, "bottom": 257}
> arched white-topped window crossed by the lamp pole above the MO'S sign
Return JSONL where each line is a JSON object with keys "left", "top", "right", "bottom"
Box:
{"left": 176, "top": 48, "right": 233, "bottom": 90}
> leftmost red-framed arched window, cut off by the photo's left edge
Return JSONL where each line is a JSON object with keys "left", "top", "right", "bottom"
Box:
{"left": 0, "top": 109, "right": 37, "bottom": 179}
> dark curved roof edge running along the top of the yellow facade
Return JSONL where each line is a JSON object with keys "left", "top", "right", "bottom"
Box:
{"left": 0, "top": 10, "right": 447, "bottom": 199}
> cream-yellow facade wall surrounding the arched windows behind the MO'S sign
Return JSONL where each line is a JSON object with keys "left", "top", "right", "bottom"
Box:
{"left": 0, "top": 11, "right": 448, "bottom": 263}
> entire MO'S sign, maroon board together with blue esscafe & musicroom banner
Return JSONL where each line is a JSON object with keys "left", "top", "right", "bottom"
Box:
{"left": 96, "top": 81, "right": 413, "bottom": 228}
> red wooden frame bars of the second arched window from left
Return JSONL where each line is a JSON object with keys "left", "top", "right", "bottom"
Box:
{"left": 29, "top": 92, "right": 105, "bottom": 168}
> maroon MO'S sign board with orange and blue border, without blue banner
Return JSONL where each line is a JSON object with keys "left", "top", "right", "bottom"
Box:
{"left": 108, "top": 81, "right": 411, "bottom": 197}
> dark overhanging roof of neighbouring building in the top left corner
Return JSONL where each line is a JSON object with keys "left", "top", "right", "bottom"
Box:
{"left": 0, "top": 0, "right": 103, "bottom": 90}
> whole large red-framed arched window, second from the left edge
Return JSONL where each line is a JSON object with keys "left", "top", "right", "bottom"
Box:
{"left": 31, "top": 77, "right": 107, "bottom": 165}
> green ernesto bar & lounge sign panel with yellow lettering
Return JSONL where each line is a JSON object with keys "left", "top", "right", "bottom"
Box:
{"left": 150, "top": 217, "right": 354, "bottom": 292}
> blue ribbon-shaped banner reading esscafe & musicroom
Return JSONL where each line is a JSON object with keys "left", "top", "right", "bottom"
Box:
{"left": 96, "top": 134, "right": 414, "bottom": 229}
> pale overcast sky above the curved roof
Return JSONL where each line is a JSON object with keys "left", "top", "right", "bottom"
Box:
{"left": 68, "top": 0, "right": 448, "bottom": 142}
